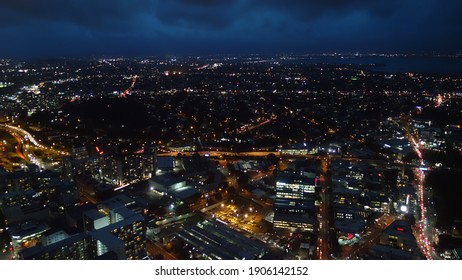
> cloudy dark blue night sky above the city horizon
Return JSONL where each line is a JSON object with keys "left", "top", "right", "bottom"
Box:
{"left": 0, "top": 0, "right": 462, "bottom": 58}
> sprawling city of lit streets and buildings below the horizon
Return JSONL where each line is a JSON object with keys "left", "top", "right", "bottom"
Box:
{"left": 0, "top": 53, "right": 462, "bottom": 260}
